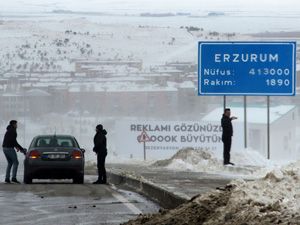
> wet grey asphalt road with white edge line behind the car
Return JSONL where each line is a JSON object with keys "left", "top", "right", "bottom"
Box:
{"left": 0, "top": 180, "right": 158, "bottom": 225}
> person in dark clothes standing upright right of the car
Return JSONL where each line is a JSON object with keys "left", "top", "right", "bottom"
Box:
{"left": 93, "top": 124, "right": 107, "bottom": 184}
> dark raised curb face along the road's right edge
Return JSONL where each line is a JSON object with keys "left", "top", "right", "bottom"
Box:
{"left": 107, "top": 171, "right": 189, "bottom": 209}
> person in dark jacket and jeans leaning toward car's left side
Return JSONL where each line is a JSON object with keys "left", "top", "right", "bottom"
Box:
{"left": 2, "top": 120, "right": 25, "bottom": 183}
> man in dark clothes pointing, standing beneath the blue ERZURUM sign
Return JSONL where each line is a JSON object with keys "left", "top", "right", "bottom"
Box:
{"left": 221, "top": 108, "right": 237, "bottom": 165}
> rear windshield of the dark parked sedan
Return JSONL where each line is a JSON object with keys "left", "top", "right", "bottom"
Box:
{"left": 33, "top": 136, "right": 78, "bottom": 148}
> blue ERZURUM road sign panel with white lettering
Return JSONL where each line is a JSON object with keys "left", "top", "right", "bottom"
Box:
{"left": 198, "top": 42, "right": 296, "bottom": 96}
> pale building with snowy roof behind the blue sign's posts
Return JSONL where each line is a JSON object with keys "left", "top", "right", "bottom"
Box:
{"left": 203, "top": 105, "right": 299, "bottom": 160}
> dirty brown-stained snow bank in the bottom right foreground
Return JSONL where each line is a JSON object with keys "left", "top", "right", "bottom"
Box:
{"left": 126, "top": 161, "right": 300, "bottom": 225}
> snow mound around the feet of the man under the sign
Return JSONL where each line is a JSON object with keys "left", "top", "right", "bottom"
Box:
{"left": 152, "top": 148, "right": 274, "bottom": 177}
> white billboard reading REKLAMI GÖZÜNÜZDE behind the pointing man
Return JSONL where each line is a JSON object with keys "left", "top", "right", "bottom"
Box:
{"left": 115, "top": 120, "right": 243, "bottom": 159}
